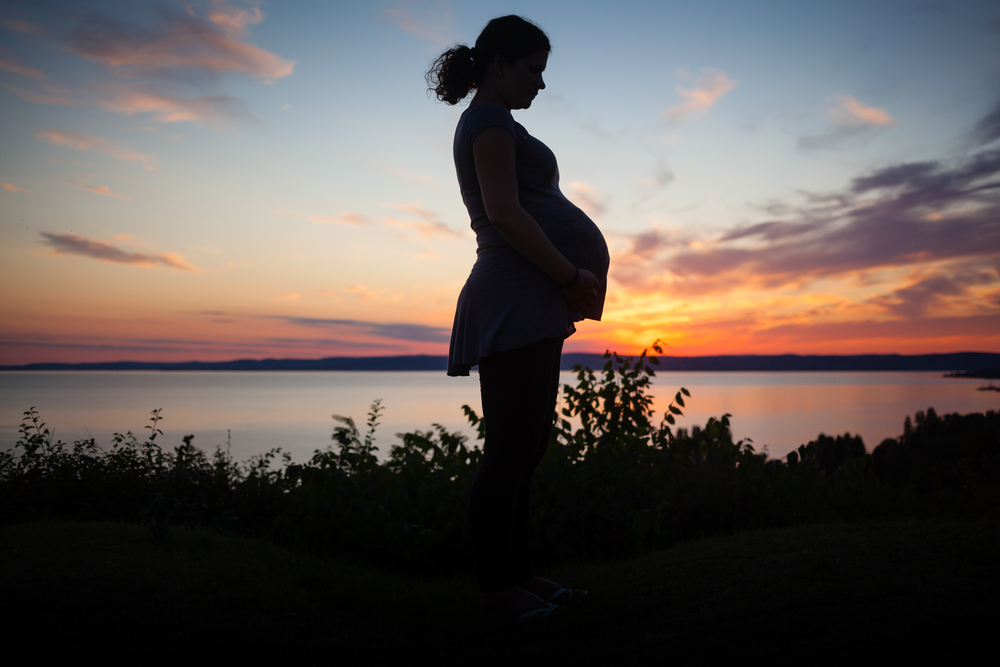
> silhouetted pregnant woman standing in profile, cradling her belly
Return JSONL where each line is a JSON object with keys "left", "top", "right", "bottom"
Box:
{"left": 427, "top": 16, "right": 609, "bottom": 620}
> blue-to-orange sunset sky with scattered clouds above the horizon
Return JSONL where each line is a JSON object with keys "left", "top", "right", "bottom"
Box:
{"left": 0, "top": 0, "right": 1000, "bottom": 364}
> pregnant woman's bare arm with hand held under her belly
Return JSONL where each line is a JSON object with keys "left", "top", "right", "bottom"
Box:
{"left": 472, "top": 126, "right": 597, "bottom": 312}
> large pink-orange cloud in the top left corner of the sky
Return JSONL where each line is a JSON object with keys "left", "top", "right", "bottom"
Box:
{"left": 7, "top": 0, "right": 295, "bottom": 127}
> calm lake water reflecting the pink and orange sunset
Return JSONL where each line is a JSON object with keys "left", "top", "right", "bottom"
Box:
{"left": 0, "top": 372, "right": 1000, "bottom": 461}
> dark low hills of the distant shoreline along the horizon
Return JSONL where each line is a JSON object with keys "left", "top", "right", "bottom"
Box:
{"left": 0, "top": 352, "right": 1000, "bottom": 378}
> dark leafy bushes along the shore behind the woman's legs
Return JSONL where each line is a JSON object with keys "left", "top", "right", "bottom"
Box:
{"left": 0, "top": 346, "right": 1000, "bottom": 569}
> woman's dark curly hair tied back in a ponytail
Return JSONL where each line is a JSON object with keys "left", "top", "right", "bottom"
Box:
{"left": 424, "top": 15, "right": 552, "bottom": 104}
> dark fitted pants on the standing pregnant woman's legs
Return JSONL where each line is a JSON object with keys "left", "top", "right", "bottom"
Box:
{"left": 469, "top": 338, "right": 563, "bottom": 593}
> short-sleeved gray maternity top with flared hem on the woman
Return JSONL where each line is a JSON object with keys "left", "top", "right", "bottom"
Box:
{"left": 448, "top": 104, "right": 610, "bottom": 375}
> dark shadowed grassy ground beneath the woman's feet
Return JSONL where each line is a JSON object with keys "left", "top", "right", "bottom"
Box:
{"left": 0, "top": 520, "right": 1000, "bottom": 665}
